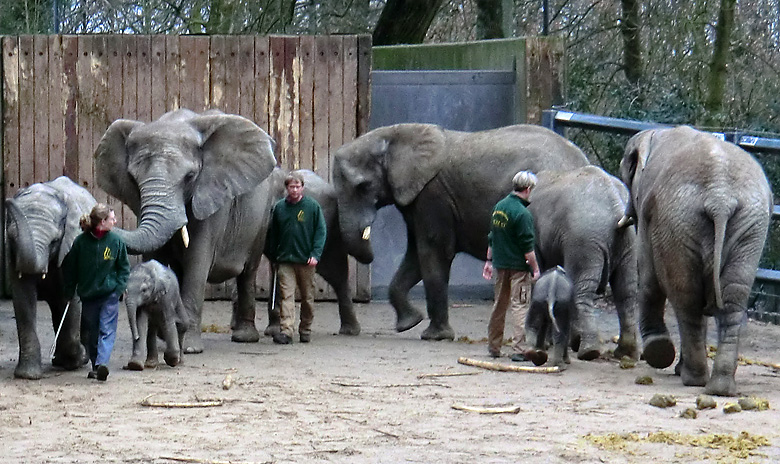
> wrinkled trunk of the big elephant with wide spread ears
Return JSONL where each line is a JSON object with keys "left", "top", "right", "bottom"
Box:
{"left": 116, "top": 178, "right": 187, "bottom": 254}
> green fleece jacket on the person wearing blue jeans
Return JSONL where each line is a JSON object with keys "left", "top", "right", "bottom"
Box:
{"left": 62, "top": 231, "right": 130, "bottom": 301}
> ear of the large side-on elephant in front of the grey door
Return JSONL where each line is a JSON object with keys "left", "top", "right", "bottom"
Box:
{"left": 385, "top": 124, "right": 446, "bottom": 206}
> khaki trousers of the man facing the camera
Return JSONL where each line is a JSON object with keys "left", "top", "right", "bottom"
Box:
{"left": 277, "top": 263, "right": 315, "bottom": 337}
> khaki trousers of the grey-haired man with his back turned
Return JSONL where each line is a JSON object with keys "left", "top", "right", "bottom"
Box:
{"left": 488, "top": 269, "right": 531, "bottom": 352}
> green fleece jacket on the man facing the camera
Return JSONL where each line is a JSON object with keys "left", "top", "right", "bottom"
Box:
{"left": 267, "top": 196, "right": 327, "bottom": 264}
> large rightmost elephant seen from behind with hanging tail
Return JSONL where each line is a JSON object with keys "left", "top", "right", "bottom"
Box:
{"left": 620, "top": 126, "right": 773, "bottom": 396}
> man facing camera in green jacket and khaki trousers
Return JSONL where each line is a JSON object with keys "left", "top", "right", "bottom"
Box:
{"left": 268, "top": 171, "right": 327, "bottom": 345}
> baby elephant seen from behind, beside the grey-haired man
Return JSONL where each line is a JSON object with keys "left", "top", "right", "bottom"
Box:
{"left": 525, "top": 266, "right": 576, "bottom": 370}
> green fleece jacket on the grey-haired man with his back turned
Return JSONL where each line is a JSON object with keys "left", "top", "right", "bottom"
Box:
{"left": 488, "top": 193, "right": 536, "bottom": 271}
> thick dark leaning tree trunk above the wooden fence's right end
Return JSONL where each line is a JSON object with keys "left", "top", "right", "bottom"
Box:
{"left": 373, "top": 0, "right": 444, "bottom": 45}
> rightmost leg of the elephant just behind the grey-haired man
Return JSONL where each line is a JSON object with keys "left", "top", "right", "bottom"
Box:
{"left": 609, "top": 254, "right": 639, "bottom": 360}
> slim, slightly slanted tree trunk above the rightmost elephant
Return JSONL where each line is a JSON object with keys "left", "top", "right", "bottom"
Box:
{"left": 704, "top": 0, "right": 737, "bottom": 117}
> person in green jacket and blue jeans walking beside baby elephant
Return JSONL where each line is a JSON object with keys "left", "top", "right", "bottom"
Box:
{"left": 63, "top": 203, "right": 130, "bottom": 381}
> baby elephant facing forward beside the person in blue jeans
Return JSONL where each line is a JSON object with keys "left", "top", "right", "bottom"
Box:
{"left": 125, "top": 260, "right": 190, "bottom": 371}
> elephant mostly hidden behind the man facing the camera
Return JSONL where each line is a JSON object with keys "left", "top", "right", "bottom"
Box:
{"left": 265, "top": 168, "right": 360, "bottom": 335}
